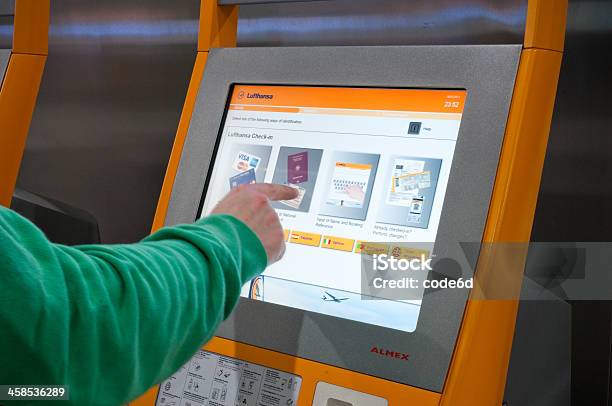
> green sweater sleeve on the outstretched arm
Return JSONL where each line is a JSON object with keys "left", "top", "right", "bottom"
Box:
{"left": 0, "top": 207, "right": 267, "bottom": 405}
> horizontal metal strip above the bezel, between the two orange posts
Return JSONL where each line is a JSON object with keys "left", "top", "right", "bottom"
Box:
{"left": 238, "top": 0, "right": 527, "bottom": 46}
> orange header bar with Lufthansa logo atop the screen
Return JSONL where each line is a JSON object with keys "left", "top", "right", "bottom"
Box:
{"left": 230, "top": 85, "right": 467, "bottom": 114}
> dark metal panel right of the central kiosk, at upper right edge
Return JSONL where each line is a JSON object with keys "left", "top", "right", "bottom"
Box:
{"left": 532, "top": 0, "right": 612, "bottom": 241}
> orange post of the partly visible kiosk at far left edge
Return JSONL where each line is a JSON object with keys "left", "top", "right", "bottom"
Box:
{"left": 0, "top": 0, "right": 50, "bottom": 207}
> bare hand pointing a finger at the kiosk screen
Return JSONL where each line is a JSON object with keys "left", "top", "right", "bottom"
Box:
{"left": 211, "top": 183, "right": 298, "bottom": 265}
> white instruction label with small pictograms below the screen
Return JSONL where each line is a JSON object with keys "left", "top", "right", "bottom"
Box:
{"left": 155, "top": 350, "right": 302, "bottom": 406}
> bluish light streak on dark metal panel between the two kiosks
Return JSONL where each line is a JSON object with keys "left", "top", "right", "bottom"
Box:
{"left": 50, "top": 20, "right": 199, "bottom": 38}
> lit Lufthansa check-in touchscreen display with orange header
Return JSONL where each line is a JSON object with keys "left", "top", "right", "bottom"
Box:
{"left": 201, "top": 85, "right": 467, "bottom": 332}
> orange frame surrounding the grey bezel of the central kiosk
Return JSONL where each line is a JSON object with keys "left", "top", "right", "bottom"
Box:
{"left": 136, "top": 0, "right": 567, "bottom": 406}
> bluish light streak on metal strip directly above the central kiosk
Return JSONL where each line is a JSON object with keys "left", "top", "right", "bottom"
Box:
{"left": 240, "top": 5, "right": 527, "bottom": 36}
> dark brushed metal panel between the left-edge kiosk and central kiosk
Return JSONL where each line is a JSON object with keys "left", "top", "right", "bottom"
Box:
{"left": 18, "top": 0, "right": 199, "bottom": 243}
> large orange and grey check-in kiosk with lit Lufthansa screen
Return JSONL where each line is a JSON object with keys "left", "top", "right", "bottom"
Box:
{"left": 133, "top": 0, "right": 567, "bottom": 406}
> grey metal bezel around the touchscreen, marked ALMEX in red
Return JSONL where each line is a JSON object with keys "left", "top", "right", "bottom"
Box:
{"left": 166, "top": 45, "right": 521, "bottom": 391}
